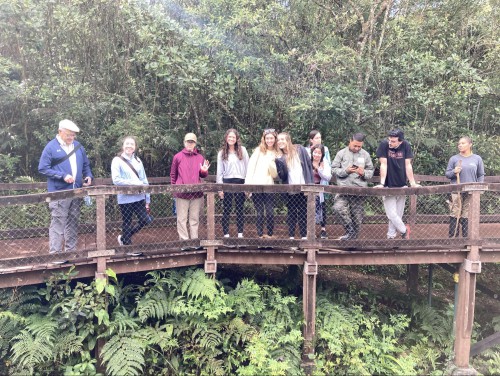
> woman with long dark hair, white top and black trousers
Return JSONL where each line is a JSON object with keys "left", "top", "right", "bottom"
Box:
{"left": 217, "top": 128, "right": 248, "bottom": 238}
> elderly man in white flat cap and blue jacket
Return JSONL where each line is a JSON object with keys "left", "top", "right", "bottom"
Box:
{"left": 38, "top": 119, "right": 93, "bottom": 253}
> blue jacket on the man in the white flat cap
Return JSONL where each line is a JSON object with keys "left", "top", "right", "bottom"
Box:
{"left": 38, "top": 138, "right": 93, "bottom": 192}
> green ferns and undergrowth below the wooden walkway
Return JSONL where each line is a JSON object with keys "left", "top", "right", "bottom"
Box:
{"left": 0, "top": 268, "right": 500, "bottom": 376}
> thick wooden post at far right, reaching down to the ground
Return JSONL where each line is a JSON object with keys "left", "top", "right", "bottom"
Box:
{"left": 454, "top": 187, "right": 484, "bottom": 371}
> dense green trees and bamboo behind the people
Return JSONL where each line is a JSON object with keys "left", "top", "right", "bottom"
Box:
{"left": 0, "top": 0, "right": 500, "bottom": 181}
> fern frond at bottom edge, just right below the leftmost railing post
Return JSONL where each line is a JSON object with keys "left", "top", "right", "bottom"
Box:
{"left": 101, "top": 335, "right": 146, "bottom": 376}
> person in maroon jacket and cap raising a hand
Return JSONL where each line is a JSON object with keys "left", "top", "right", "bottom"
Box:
{"left": 170, "top": 133, "right": 210, "bottom": 240}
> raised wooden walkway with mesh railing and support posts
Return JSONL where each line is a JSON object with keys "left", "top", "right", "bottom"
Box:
{"left": 0, "top": 175, "right": 500, "bottom": 374}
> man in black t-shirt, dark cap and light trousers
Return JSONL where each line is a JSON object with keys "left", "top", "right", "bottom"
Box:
{"left": 375, "top": 128, "right": 419, "bottom": 239}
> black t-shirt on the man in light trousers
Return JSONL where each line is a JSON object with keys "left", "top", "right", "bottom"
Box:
{"left": 377, "top": 140, "right": 413, "bottom": 188}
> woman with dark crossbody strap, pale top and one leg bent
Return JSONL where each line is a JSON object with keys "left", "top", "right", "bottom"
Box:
{"left": 111, "top": 136, "right": 152, "bottom": 245}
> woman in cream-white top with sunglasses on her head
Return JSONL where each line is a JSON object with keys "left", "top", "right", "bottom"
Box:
{"left": 245, "top": 128, "right": 278, "bottom": 238}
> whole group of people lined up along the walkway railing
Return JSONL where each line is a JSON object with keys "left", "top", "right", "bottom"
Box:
{"left": 38, "top": 119, "right": 484, "bottom": 253}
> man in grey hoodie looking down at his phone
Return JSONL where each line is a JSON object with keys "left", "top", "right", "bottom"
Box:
{"left": 332, "top": 133, "right": 374, "bottom": 240}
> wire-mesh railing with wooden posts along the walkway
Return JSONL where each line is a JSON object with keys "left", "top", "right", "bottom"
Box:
{"left": 0, "top": 183, "right": 500, "bottom": 271}
